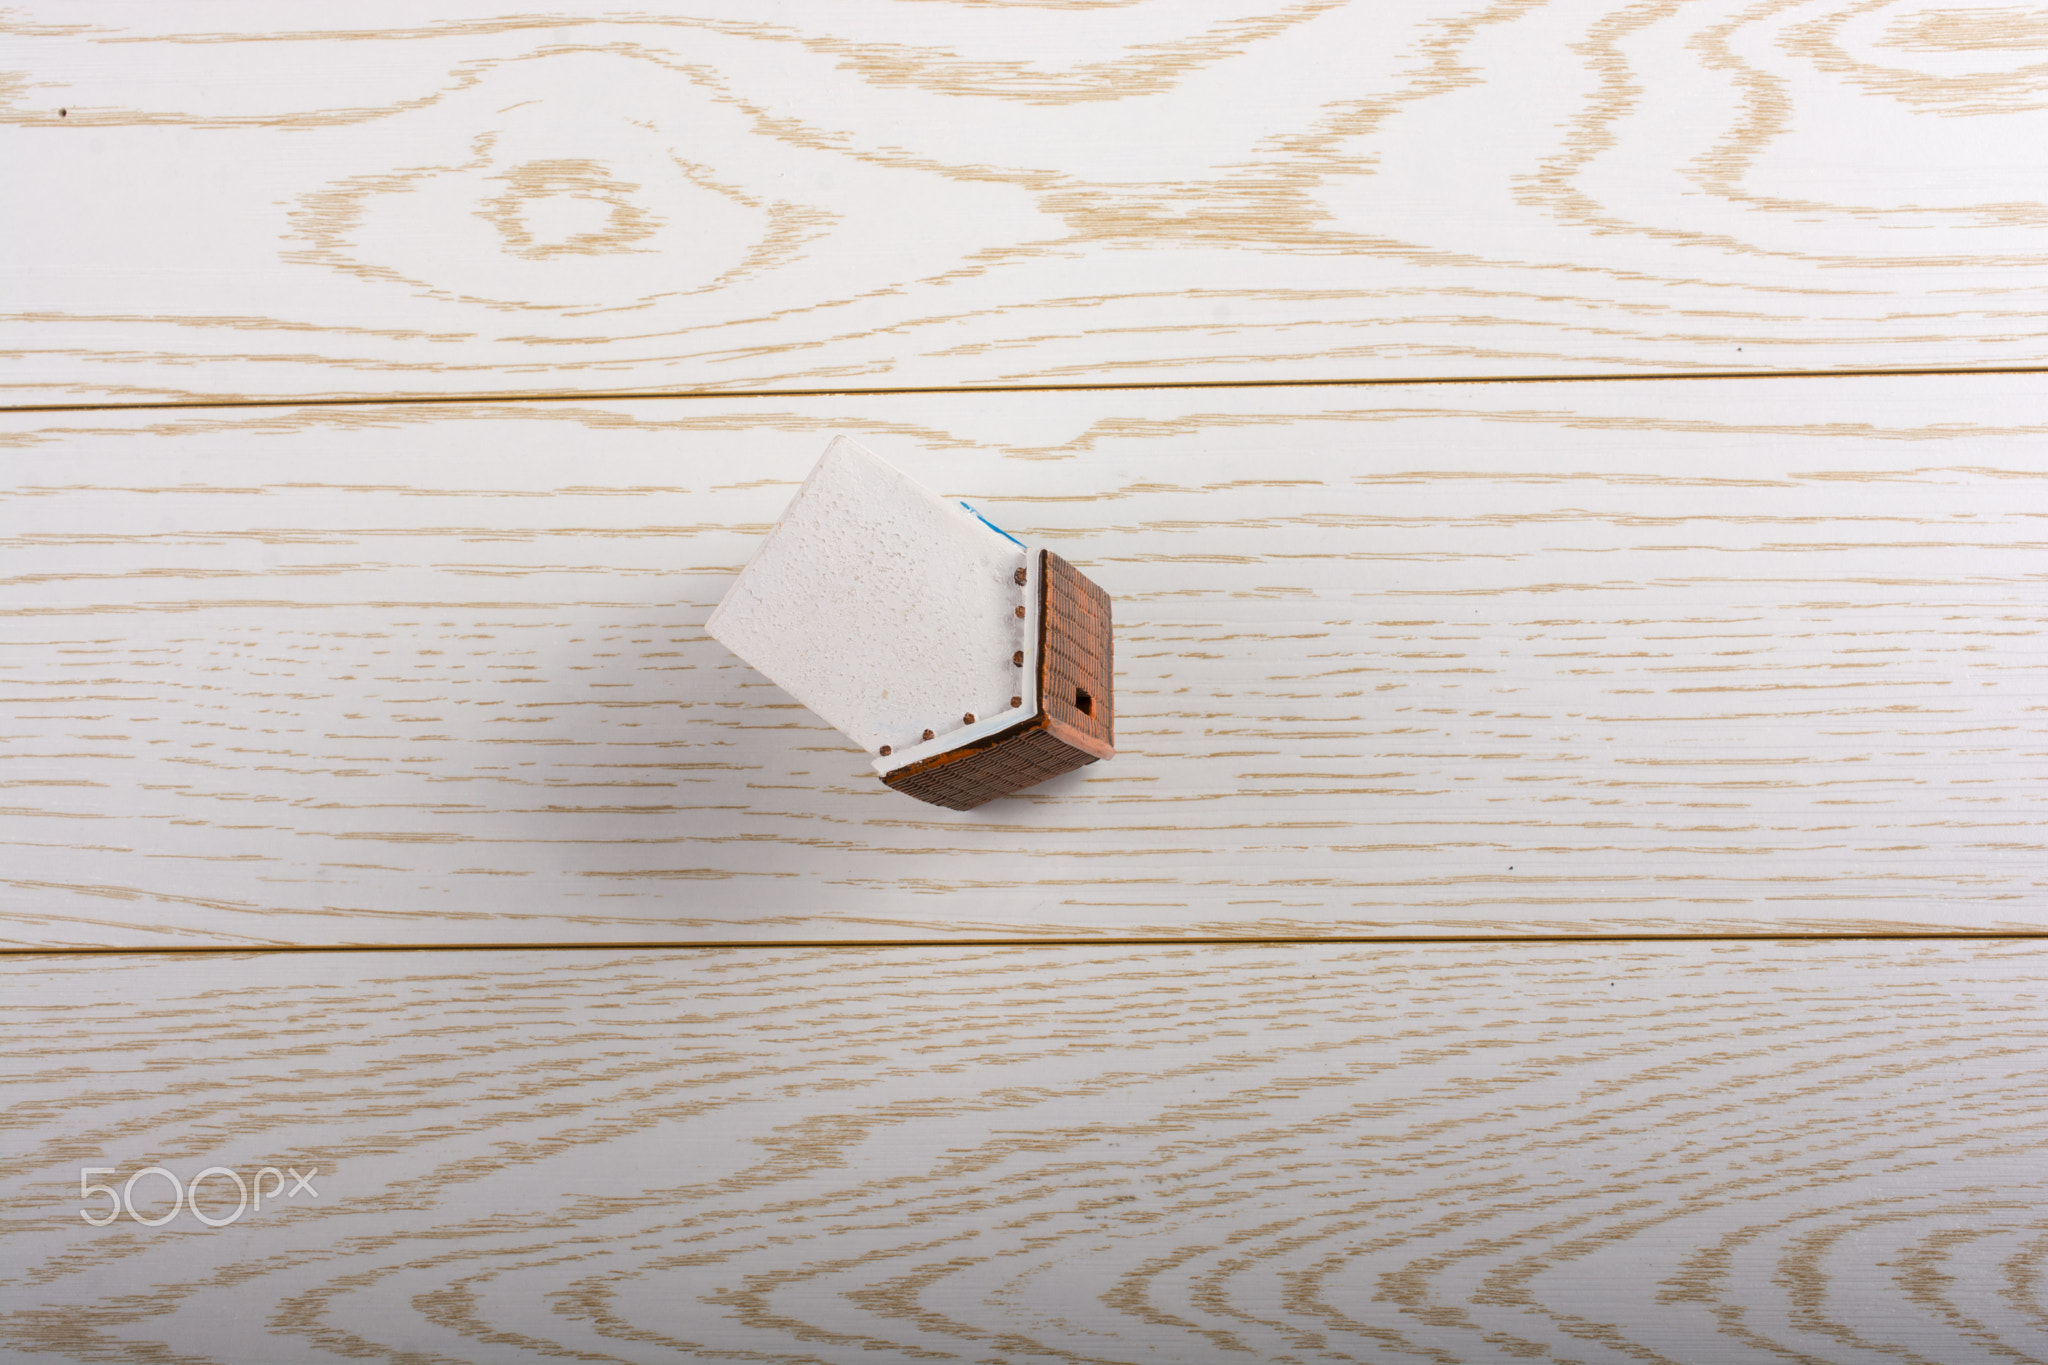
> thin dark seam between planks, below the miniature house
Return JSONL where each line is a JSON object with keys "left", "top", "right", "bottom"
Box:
{"left": 0, "top": 929, "right": 2048, "bottom": 958}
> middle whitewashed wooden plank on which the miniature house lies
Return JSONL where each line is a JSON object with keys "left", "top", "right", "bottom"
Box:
{"left": 0, "top": 377, "right": 2048, "bottom": 948}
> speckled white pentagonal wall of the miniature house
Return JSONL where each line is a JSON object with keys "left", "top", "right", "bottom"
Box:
{"left": 705, "top": 436, "right": 1026, "bottom": 751}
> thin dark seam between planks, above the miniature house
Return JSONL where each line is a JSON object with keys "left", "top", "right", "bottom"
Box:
{"left": 0, "top": 364, "right": 2048, "bottom": 413}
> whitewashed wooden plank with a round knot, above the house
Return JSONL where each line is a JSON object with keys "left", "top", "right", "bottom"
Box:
{"left": 0, "top": 0, "right": 2048, "bottom": 403}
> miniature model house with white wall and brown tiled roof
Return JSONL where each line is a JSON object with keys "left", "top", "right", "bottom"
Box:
{"left": 707, "top": 438, "right": 1116, "bottom": 810}
